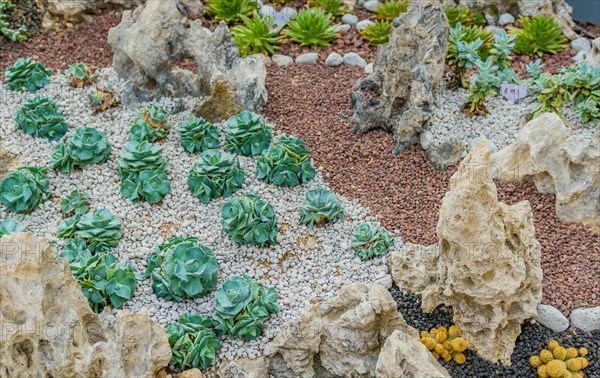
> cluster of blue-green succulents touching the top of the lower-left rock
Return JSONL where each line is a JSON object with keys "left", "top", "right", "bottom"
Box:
{"left": 60, "top": 239, "right": 141, "bottom": 313}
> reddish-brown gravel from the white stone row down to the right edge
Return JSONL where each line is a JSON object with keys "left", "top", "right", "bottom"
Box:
{"left": 265, "top": 65, "right": 600, "bottom": 314}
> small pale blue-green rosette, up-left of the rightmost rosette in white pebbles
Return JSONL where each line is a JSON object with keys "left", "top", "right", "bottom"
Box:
{"left": 300, "top": 189, "right": 344, "bottom": 228}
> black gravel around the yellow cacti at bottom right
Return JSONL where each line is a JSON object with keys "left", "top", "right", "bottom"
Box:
{"left": 390, "top": 286, "right": 600, "bottom": 378}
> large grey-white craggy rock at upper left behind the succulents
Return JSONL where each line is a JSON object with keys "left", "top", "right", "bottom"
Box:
{"left": 108, "top": 0, "right": 267, "bottom": 111}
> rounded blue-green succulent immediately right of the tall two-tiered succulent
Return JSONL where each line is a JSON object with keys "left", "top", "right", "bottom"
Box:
{"left": 188, "top": 150, "right": 246, "bottom": 203}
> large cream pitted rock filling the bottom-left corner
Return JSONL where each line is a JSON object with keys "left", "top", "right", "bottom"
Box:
{"left": 0, "top": 232, "right": 171, "bottom": 377}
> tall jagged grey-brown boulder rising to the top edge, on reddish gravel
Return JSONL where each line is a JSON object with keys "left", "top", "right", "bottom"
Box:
{"left": 350, "top": 0, "right": 448, "bottom": 153}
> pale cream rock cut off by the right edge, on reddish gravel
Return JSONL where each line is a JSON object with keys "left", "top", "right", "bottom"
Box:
{"left": 493, "top": 113, "right": 600, "bottom": 226}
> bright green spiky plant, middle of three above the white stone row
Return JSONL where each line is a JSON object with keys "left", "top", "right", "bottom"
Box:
{"left": 284, "top": 8, "right": 339, "bottom": 47}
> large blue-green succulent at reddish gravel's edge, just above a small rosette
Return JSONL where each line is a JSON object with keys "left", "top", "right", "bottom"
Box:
{"left": 256, "top": 137, "right": 316, "bottom": 186}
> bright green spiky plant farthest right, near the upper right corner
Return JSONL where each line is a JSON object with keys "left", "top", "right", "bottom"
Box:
{"left": 509, "top": 14, "right": 567, "bottom": 56}
